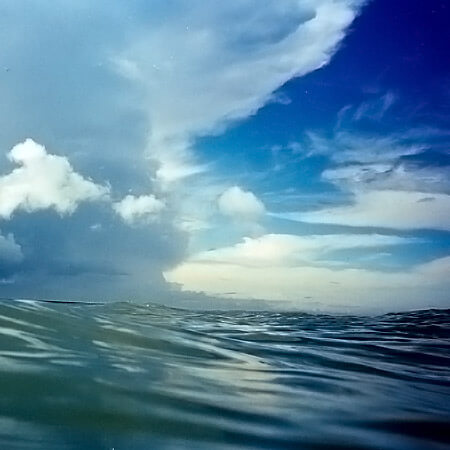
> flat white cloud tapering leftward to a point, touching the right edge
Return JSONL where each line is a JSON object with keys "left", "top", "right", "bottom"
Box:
{"left": 298, "top": 190, "right": 450, "bottom": 230}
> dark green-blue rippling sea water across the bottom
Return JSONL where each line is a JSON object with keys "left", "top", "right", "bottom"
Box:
{"left": 0, "top": 301, "right": 450, "bottom": 450}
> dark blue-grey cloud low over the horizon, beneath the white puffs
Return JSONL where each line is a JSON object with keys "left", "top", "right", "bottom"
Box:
{"left": 0, "top": 205, "right": 186, "bottom": 300}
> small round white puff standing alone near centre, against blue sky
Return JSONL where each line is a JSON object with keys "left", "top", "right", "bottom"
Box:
{"left": 218, "top": 186, "right": 265, "bottom": 222}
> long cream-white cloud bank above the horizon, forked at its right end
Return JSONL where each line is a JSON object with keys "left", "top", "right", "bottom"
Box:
{"left": 165, "top": 235, "right": 450, "bottom": 312}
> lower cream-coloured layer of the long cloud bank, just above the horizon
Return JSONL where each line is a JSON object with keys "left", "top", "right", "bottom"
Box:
{"left": 165, "top": 248, "right": 450, "bottom": 311}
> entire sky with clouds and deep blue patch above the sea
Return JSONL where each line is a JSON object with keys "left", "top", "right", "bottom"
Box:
{"left": 0, "top": 0, "right": 450, "bottom": 312}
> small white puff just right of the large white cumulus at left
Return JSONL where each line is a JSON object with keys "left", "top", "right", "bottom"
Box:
{"left": 113, "top": 195, "right": 165, "bottom": 225}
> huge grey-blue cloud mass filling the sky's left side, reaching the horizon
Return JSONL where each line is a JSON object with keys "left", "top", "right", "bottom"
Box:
{"left": 0, "top": 0, "right": 368, "bottom": 306}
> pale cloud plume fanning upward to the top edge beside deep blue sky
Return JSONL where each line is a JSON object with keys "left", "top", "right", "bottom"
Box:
{"left": 113, "top": 0, "right": 363, "bottom": 187}
